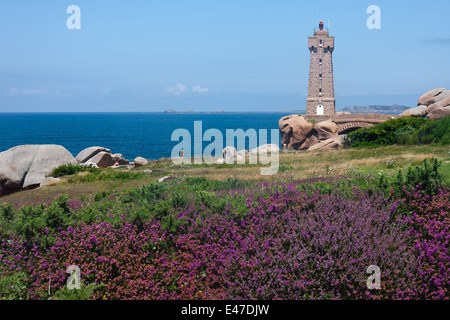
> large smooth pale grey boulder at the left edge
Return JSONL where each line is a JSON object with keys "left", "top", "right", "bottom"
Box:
{"left": 0, "top": 145, "right": 77, "bottom": 194}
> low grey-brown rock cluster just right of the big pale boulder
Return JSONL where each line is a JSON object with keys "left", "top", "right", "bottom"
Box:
{"left": 75, "top": 147, "right": 130, "bottom": 168}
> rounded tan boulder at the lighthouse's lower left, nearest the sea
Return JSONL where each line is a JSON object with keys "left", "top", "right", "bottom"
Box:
{"left": 278, "top": 115, "right": 314, "bottom": 149}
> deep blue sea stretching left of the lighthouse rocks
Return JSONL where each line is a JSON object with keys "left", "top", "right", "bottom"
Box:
{"left": 0, "top": 113, "right": 288, "bottom": 161}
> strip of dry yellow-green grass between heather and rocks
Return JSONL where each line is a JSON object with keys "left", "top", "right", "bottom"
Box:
{"left": 0, "top": 145, "right": 450, "bottom": 206}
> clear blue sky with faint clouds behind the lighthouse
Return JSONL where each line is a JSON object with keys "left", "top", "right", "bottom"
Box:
{"left": 0, "top": 0, "right": 450, "bottom": 112}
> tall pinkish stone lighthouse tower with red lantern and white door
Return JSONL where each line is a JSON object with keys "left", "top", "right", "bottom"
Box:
{"left": 306, "top": 21, "right": 336, "bottom": 116}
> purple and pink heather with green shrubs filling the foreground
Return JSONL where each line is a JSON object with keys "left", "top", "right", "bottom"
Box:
{"left": 0, "top": 159, "right": 450, "bottom": 299}
